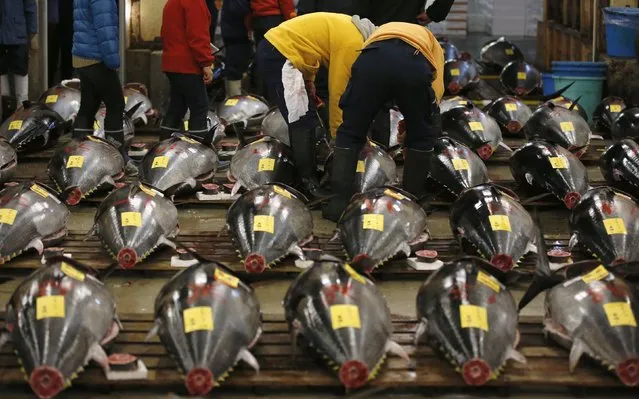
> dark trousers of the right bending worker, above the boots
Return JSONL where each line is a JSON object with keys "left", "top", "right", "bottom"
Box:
{"left": 335, "top": 39, "right": 440, "bottom": 151}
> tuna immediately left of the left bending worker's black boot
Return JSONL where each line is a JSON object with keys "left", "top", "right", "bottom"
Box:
{"left": 229, "top": 136, "right": 296, "bottom": 194}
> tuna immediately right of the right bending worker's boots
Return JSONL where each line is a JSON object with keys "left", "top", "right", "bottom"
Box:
{"left": 429, "top": 137, "right": 490, "bottom": 195}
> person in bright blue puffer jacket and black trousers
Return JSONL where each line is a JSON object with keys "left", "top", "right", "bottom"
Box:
{"left": 73, "top": 0, "right": 127, "bottom": 159}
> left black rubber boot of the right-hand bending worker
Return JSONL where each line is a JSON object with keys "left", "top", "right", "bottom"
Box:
{"left": 322, "top": 147, "right": 358, "bottom": 222}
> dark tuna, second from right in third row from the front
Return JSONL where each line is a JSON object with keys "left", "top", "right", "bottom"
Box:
{"left": 510, "top": 140, "right": 589, "bottom": 209}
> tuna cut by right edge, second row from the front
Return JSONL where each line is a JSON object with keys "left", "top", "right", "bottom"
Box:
{"left": 569, "top": 186, "right": 639, "bottom": 266}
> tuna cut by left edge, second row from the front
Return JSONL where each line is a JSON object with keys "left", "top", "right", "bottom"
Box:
{"left": 0, "top": 181, "right": 69, "bottom": 264}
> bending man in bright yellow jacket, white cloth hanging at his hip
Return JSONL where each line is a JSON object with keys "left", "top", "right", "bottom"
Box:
{"left": 257, "top": 12, "right": 375, "bottom": 197}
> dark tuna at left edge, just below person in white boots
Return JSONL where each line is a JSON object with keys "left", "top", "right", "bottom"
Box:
{"left": 0, "top": 102, "right": 64, "bottom": 152}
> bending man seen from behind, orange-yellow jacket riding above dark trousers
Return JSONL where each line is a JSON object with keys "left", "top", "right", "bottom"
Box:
{"left": 323, "top": 22, "right": 444, "bottom": 221}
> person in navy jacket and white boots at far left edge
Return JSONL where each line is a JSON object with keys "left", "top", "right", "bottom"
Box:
{"left": 0, "top": 0, "right": 38, "bottom": 108}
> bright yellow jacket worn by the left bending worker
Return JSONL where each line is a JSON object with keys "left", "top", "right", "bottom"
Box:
{"left": 264, "top": 12, "right": 364, "bottom": 137}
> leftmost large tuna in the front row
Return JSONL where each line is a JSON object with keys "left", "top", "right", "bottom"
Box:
{"left": 0, "top": 257, "right": 120, "bottom": 399}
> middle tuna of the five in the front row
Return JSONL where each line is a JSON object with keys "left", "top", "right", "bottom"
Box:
{"left": 283, "top": 257, "right": 408, "bottom": 388}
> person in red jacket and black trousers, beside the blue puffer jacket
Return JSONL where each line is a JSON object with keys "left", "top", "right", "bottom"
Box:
{"left": 160, "top": 0, "right": 214, "bottom": 145}
